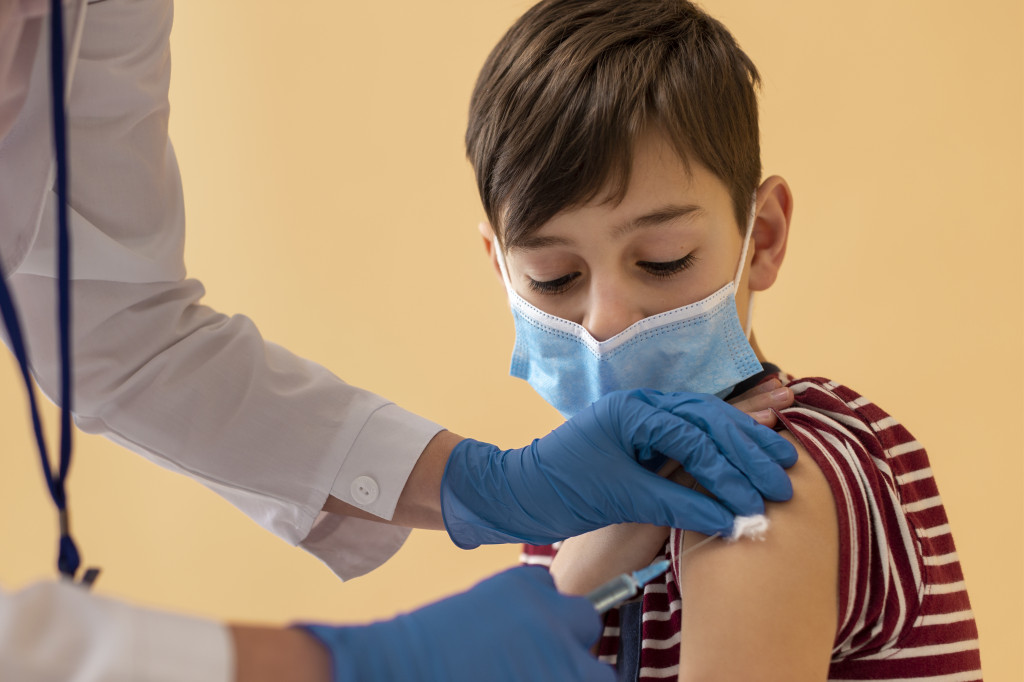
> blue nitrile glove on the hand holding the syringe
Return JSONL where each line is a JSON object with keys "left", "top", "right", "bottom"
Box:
{"left": 299, "top": 566, "right": 615, "bottom": 682}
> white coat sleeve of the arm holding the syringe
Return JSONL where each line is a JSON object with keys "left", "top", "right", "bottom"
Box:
{"left": 0, "top": 583, "right": 233, "bottom": 682}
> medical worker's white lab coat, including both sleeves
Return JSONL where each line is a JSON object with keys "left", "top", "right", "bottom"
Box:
{"left": 0, "top": 0, "right": 440, "bottom": 682}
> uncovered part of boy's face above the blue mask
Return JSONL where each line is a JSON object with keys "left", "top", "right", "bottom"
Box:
{"left": 481, "top": 135, "right": 755, "bottom": 341}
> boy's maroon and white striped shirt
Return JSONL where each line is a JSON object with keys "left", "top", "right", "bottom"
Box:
{"left": 523, "top": 374, "right": 982, "bottom": 682}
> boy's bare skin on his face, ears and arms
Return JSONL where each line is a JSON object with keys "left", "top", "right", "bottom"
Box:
{"left": 480, "top": 133, "right": 839, "bottom": 682}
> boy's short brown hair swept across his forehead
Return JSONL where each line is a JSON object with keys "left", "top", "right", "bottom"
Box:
{"left": 466, "top": 0, "right": 761, "bottom": 249}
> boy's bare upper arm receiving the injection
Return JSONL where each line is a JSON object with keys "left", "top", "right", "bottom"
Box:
{"left": 679, "top": 432, "right": 839, "bottom": 682}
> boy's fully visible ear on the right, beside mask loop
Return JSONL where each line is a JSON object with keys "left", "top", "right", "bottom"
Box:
{"left": 748, "top": 175, "right": 793, "bottom": 291}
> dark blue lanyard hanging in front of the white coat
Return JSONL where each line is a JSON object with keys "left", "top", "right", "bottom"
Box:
{"left": 0, "top": 0, "right": 99, "bottom": 585}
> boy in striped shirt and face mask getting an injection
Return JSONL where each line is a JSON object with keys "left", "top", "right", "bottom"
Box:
{"left": 467, "top": 0, "right": 981, "bottom": 681}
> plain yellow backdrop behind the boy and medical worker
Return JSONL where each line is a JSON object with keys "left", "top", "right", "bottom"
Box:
{"left": 0, "top": 0, "right": 1024, "bottom": 680}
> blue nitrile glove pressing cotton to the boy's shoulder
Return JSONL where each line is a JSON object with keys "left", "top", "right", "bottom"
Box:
{"left": 441, "top": 390, "right": 797, "bottom": 549}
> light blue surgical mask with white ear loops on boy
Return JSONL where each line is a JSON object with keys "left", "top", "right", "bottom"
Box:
{"left": 498, "top": 199, "right": 762, "bottom": 418}
